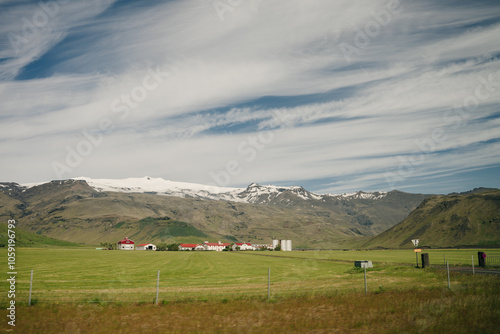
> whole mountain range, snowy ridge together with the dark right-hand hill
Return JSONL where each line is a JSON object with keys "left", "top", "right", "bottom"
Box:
{"left": 0, "top": 177, "right": 500, "bottom": 249}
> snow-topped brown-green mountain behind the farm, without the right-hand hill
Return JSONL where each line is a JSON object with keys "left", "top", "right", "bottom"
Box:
{"left": 0, "top": 177, "right": 429, "bottom": 248}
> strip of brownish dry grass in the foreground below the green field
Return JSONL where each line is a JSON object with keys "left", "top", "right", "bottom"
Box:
{"left": 6, "top": 275, "right": 500, "bottom": 334}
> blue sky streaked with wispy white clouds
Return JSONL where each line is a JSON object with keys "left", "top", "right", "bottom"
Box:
{"left": 0, "top": 0, "right": 500, "bottom": 194}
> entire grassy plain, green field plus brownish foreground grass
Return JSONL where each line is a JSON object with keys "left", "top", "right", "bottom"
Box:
{"left": 0, "top": 248, "right": 500, "bottom": 333}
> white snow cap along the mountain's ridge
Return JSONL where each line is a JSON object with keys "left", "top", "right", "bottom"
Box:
{"left": 24, "top": 176, "right": 387, "bottom": 205}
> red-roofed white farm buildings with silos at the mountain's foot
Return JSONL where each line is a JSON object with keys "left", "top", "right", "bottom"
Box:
{"left": 114, "top": 238, "right": 292, "bottom": 252}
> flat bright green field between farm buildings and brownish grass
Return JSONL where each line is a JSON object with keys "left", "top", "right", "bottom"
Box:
{"left": 0, "top": 248, "right": 500, "bottom": 304}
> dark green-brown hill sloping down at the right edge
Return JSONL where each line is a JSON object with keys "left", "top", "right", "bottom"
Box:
{"left": 363, "top": 190, "right": 500, "bottom": 248}
